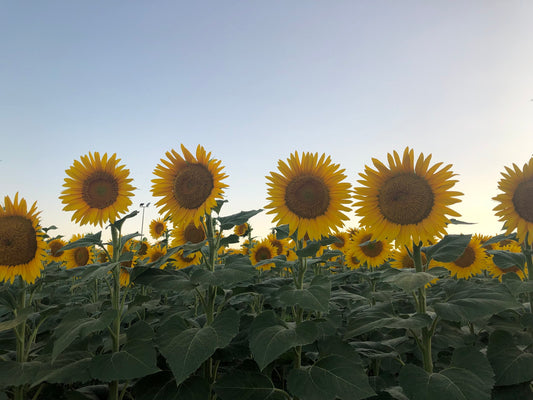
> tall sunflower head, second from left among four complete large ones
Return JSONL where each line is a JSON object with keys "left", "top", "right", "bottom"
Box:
{"left": 152, "top": 145, "right": 228, "bottom": 226}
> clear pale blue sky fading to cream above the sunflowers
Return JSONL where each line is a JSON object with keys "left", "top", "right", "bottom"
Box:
{"left": 0, "top": 0, "right": 533, "bottom": 238}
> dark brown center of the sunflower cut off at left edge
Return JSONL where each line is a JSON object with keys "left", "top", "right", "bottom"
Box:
{"left": 0, "top": 215, "right": 37, "bottom": 266}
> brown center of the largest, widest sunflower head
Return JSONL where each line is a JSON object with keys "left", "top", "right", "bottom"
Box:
{"left": 378, "top": 173, "right": 434, "bottom": 225}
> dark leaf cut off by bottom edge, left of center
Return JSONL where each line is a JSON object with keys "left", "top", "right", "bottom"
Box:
{"left": 214, "top": 371, "right": 287, "bottom": 400}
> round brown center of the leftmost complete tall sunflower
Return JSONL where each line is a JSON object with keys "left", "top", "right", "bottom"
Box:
{"left": 82, "top": 171, "right": 118, "bottom": 210}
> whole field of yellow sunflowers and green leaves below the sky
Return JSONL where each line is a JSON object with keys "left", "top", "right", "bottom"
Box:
{"left": 0, "top": 145, "right": 533, "bottom": 400}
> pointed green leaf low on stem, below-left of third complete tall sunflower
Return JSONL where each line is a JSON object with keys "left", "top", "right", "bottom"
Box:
{"left": 250, "top": 310, "right": 318, "bottom": 370}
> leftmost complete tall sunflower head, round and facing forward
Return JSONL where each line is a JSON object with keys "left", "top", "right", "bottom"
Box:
{"left": 59, "top": 152, "right": 135, "bottom": 226}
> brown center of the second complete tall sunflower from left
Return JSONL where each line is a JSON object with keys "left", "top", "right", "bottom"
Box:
{"left": 173, "top": 164, "right": 214, "bottom": 209}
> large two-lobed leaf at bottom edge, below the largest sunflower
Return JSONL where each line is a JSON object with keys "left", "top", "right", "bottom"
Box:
{"left": 399, "top": 347, "right": 494, "bottom": 400}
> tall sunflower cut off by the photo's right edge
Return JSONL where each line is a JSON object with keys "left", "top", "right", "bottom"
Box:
{"left": 493, "top": 157, "right": 533, "bottom": 244}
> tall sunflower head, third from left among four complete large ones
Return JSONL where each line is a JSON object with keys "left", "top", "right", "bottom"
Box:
{"left": 265, "top": 152, "right": 350, "bottom": 240}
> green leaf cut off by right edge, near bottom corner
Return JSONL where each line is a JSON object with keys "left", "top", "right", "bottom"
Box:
{"left": 487, "top": 330, "right": 533, "bottom": 386}
